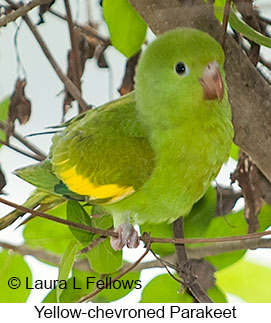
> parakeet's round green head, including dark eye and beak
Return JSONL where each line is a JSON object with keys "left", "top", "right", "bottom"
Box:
{"left": 135, "top": 28, "right": 228, "bottom": 127}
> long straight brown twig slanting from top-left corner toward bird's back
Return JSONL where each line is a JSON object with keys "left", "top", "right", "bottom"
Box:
{"left": 5, "top": 0, "right": 89, "bottom": 110}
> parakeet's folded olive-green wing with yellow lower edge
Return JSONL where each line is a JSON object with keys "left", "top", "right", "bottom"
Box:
{"left": 51, "top": 94, "right": 154, "bottom": 204}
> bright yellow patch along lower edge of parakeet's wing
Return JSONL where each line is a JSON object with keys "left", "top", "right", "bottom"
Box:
{"left": 60, "top": 167, "right": 135, "bottom": 203}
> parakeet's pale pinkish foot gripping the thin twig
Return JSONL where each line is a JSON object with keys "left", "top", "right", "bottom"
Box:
{"left": 110, "top": 223, "right": 139, "bottom": 250}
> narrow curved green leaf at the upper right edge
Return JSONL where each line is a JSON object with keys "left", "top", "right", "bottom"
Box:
{"left": 229, "top": 10, "right": 271, "bottom": 48}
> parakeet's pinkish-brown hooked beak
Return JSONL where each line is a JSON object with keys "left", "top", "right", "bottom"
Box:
{"left": 200, "top": 61, "right": 224, "bottom": 101}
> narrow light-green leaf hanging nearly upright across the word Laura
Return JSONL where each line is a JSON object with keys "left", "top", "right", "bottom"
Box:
{"left": 56, "top": 239, "right": 78, "bottom": 302}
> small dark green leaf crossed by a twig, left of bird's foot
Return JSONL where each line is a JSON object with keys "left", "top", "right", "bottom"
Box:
{"left": 67, "top": 201, "right": 94, "bottom": 243}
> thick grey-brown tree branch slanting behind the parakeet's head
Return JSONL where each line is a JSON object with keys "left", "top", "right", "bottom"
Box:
{"left": 129, "top": 0, "right": 271, "bottom": 181}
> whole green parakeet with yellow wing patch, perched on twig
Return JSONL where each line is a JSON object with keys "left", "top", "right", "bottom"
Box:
{"left": 0, "top": 28, "right": 233, "bottom": 250}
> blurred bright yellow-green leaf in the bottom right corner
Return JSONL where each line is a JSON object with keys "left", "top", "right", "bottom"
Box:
{"left": 216, "top": 260, "right": 271, "bottom": 303}
